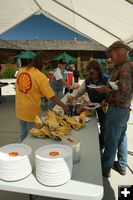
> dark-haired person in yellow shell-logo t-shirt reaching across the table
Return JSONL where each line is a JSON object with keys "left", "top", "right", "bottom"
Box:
{"left": 16, "top": 52, "right": 68, "bottom": 141}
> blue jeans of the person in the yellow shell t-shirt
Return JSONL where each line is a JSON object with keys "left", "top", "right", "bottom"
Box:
{"left": 19, "top": 120, "right": 35, "bottom": 142}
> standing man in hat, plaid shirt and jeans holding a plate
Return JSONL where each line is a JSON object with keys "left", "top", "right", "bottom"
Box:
{"left": 97, "top": 41, "right": 133, "bottom": 178}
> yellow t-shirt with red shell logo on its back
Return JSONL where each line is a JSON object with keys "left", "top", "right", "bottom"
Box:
{"left": 16, "top": 67, "right": 55, "bottom": 122}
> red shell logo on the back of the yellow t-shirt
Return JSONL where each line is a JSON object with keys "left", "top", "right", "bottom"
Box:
{"left": 17, "top": 72, "right": 32, "bottom": 94}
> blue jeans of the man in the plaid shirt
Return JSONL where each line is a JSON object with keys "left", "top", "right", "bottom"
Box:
{"left": 102, "top": 106, "right": 130, "bottom": 172}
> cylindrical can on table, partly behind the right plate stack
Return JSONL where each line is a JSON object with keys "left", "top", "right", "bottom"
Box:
{"left": 61, "top": 135, "right": 80, "bottom": 163}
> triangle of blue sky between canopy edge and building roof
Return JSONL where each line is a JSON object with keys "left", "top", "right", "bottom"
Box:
{"left": 0, "top": 14, "right": 88, "bottom": 40}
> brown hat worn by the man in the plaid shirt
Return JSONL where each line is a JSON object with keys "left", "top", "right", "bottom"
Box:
{"left": 106, "top": 41, "right": 131, "bottom": 57}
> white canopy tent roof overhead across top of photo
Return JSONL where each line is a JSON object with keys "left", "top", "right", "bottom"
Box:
{"left": 0, "top": 0, "right": 133, "bottom": 48}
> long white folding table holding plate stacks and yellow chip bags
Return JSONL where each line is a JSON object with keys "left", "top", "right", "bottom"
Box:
{"left": 0, "top": 114, "right": 103, "bottom": 200}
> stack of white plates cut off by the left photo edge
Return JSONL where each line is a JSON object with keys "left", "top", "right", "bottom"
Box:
{"left": 0, "top": 143, "right": 32, "bottom": 181}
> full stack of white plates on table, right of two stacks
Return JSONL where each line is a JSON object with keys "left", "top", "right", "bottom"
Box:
{"left": 35, "top": 144, "right": 73, "bottom": 186}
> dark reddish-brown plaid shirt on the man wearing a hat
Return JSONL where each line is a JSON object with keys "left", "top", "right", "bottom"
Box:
{"left": 107, "top": 61, "right": 133, "bottom": 108}
